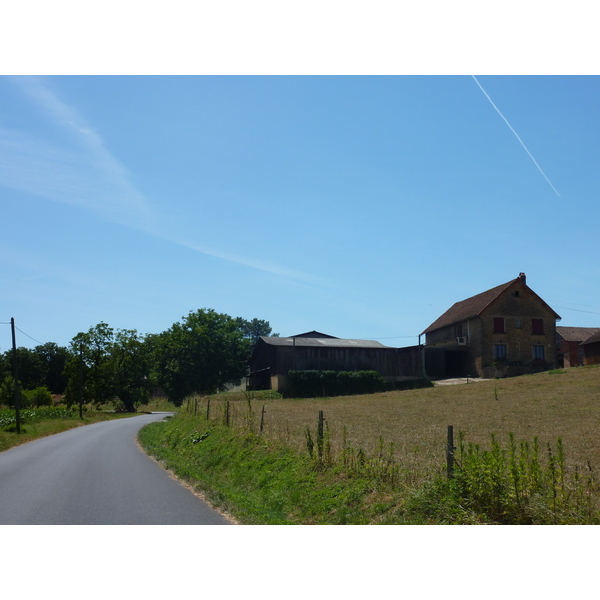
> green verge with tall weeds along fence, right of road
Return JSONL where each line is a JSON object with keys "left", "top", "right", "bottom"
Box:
{"left": 139, "top": 406, "right": 600, "bottom": 524}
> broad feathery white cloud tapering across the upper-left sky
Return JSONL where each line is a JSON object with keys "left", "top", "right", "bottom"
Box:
{"left": 0, "top": 77, "right": 315, "bottom": 284}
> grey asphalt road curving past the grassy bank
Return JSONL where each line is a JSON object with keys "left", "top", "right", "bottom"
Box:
{"left": 0, "top": 413, "right": 229, "bottom": 525}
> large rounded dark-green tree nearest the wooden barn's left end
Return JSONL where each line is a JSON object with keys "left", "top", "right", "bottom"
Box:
{"left": 152, "top": 309, "right": 250, "bottom": 405}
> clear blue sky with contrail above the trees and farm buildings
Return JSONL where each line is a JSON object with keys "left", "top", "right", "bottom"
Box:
{"left": 0, "top": 75, "right": 600, "bottom": 351}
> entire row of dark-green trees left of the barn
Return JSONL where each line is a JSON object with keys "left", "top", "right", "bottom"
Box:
{"left": 0, "top": 309, "right": 279, "bottom": 412}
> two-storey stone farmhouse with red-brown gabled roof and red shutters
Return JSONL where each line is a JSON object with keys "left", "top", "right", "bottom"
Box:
{"left": 423, "top": 273, "right": 560, "bottom": 378}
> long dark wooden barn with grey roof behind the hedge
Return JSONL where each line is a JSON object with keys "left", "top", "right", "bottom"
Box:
{"left": 248, "top": 331, "right": 420, "bottom": 391}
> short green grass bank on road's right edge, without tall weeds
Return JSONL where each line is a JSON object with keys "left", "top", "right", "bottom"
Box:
{"left": 139, "top": 415, "right": 408, "bottom": 524}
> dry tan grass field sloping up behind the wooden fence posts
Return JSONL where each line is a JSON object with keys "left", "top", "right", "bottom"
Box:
{"left": 203, "top": 360, "right": 600, "bottom": 479}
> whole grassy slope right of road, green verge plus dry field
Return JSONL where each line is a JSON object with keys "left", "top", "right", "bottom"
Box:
{"left": 140, "top": 368, "right": 600, "bottom": 524}
